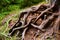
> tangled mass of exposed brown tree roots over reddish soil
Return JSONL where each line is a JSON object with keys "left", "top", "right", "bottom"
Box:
{"left": 9, "top": 4, "right": 60, "bottom": 40}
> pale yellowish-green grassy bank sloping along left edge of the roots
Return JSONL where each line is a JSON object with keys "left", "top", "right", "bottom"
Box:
{"left": 0, "top": 4, "right": 45, "bottom": 40}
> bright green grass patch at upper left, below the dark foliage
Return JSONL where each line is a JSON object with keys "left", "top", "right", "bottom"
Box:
{"left": 0, "top": 5, "right": 20, "bottom": 21}
